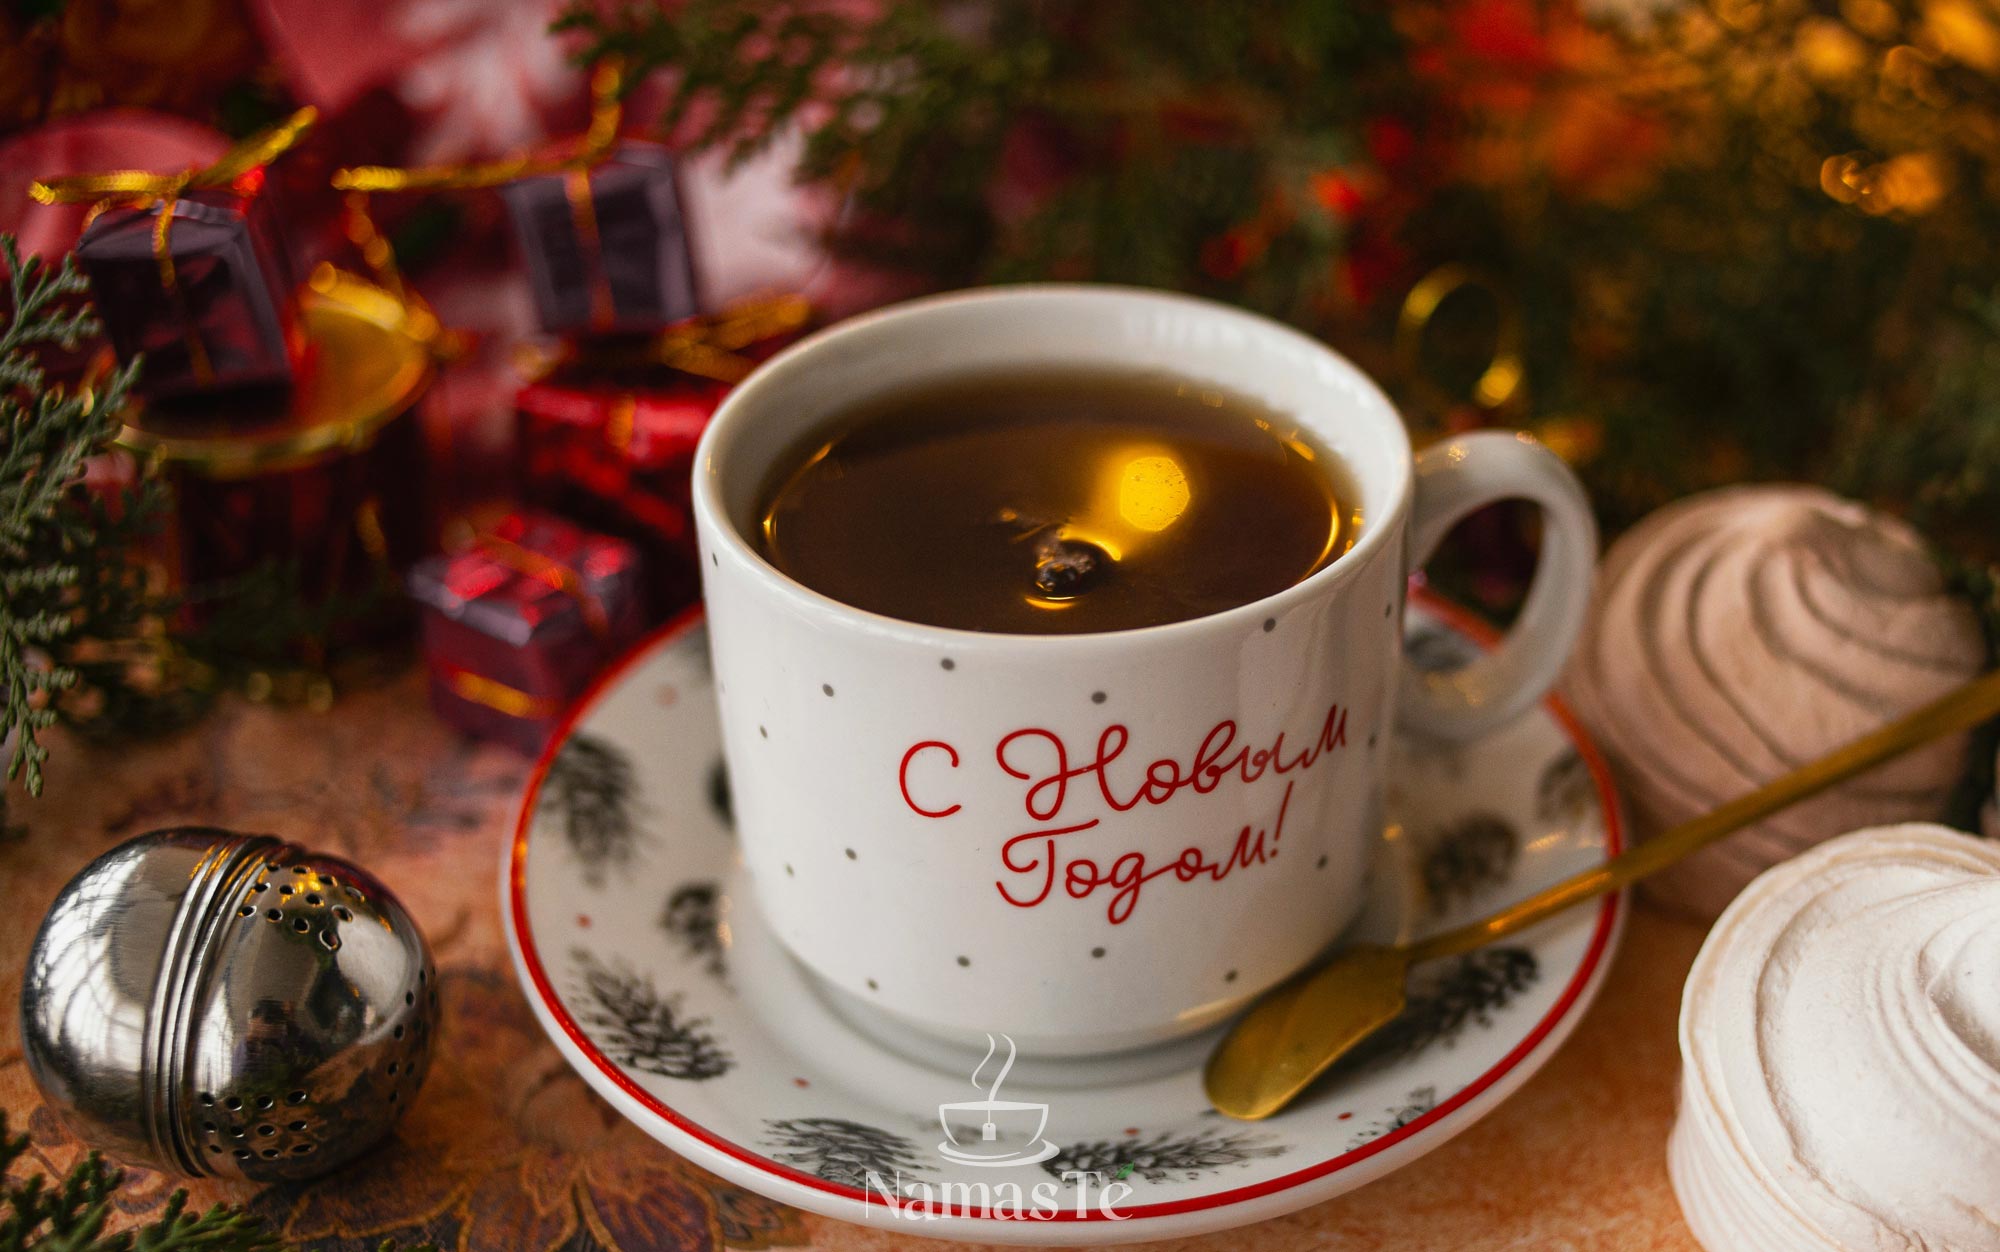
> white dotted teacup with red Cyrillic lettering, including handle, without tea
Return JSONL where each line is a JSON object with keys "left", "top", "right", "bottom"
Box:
{"left": 694, "top": 286, "right": 1596, "bottom": 1056}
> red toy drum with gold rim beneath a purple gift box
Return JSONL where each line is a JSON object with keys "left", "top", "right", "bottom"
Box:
{"left": 118, "top": 266, "right": 436, "bottom": 668}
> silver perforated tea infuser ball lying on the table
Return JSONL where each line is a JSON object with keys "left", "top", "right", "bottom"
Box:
{"left": 20, "top": 826, "right": 438, "bottom": 1182}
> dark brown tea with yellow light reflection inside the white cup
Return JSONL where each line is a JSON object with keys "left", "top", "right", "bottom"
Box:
{"left": 758, "top": 370, "right": 1362, "bottom": 634}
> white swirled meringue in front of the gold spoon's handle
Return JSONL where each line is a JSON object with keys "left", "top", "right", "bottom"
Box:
{"left": 1668, "top": 824, "right": 2000, "bottom": 1252}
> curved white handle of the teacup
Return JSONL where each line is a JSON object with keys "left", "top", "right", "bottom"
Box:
{"left": 1398, "top": 430, "right": 1598, "bottom": 740}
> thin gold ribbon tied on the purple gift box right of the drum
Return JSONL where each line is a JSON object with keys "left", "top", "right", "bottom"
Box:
{"left": 334, "top": 58, "right": 624, "bottom": 326}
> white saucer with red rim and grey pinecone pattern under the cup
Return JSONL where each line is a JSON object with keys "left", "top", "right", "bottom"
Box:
{"left": 502, "top": 602, "right": 1624, "bottom": 1244}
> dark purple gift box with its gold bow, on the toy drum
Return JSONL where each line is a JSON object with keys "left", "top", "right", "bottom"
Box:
{"left": 28, "top": 108, "right": 318, "bottom": 396}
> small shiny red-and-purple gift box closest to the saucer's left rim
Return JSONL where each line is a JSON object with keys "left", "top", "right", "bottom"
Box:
{"left": 410, "top": 512, "right": 646, "bottom": 756}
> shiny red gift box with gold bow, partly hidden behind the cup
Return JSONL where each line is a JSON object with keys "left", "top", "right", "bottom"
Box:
{"left": 514, "top": 296, "right": 812, "bottom": 618}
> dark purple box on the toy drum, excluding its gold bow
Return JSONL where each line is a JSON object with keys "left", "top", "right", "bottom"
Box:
{"left": 76, "top": 190, "right": 300, "bottom": 396}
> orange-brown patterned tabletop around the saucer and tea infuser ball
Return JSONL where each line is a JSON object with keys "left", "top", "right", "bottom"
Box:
{"left": 0, "top": 674, "right": 1704, "bottom": 1252}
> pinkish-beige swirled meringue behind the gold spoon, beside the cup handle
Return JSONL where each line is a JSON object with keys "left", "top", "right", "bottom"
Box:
{"left": 1566, "top": 486, "right": 1986, "bottom": 916}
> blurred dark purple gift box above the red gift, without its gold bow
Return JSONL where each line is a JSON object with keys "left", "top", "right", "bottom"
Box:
{"left": 500, "top": 142, "right": 700, "bottom": 334}
